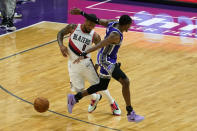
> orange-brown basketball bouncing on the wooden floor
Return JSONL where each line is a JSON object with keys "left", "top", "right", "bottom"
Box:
{"left": 34, "top": 97, "right": 49, "bottom": 113}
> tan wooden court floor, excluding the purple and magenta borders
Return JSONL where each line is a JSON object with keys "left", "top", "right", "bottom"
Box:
{"left": 0, "top": 22, "right": 197, "bottom": 131}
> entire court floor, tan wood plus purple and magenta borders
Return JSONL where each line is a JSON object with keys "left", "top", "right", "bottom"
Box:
{"left": 0, "top": 0, "right": 197, "bottom": 131}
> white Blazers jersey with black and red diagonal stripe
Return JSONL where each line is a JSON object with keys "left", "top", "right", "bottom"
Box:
{"left": 69, "top": 24, "right": 94, "bottom": 59}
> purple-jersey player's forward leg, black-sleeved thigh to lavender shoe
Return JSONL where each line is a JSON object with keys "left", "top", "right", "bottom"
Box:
{"left": 112, "top": 64, "right": 144, "bottom": 122}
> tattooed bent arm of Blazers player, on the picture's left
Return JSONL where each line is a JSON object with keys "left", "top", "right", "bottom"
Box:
{"left": 57, "top": 24, "right": 77, "bottom": 57}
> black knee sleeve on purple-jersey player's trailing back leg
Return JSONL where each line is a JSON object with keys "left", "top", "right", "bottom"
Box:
{"left": 87, "top": 78, "right": 110, "bottom": 94}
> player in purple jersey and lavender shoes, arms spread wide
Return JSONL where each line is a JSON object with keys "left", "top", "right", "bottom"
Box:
{"left": 68, "top": 8, "right": 144, "bottom": 122}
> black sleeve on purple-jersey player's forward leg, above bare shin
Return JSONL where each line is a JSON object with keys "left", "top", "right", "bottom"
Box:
{"left": 112, "top": 64, "right": 127, "bottom": 80}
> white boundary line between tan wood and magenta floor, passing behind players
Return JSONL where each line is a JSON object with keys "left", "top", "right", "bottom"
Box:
{"left": 45, "top": 21, "right": 197, "bottom": 39}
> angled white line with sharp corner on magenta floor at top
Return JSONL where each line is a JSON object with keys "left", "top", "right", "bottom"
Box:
{"left": 85, "top": 0, "right": 197, "bottom": 20}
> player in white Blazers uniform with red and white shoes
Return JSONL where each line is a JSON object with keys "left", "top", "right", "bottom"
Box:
{"left": 57, "top": 14, "right": 121, "bottom": 115}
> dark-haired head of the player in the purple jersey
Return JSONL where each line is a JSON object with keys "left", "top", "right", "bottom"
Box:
{"left": 119, "top": 15, "right": 132, "bottom": 32}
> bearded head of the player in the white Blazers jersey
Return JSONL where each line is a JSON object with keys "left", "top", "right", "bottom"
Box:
{"left": 84, "top": 14, "right": 96, "bottom": 33}
